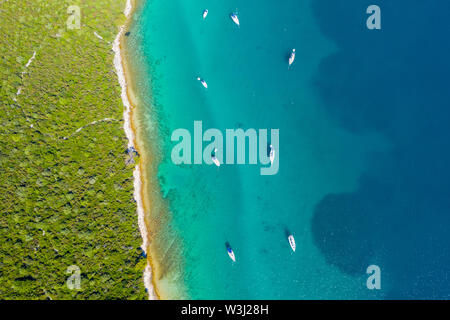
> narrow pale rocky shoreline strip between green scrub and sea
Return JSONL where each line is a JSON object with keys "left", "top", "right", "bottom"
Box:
{"left": 112, "top": 0, "right": 160, "bottom": 300}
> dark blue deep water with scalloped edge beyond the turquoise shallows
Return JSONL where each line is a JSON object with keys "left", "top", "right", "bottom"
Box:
{"left": 312, "top": 0, "right": 450, "bottom": 299}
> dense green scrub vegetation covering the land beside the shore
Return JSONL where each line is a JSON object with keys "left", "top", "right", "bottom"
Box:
{"left": 0, "top": 0, "right": 146, "bottom": 299}
